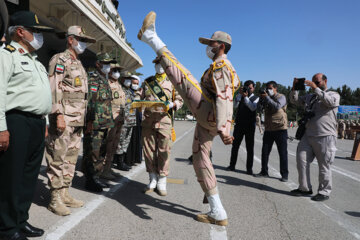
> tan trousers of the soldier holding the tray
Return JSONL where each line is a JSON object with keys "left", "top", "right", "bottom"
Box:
{"left": 141, "top": 120, "right": 172, "bottom": 176}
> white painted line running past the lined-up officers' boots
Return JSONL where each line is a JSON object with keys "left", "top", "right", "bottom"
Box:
{"left": 45, "top": 126, "right": 195, "bottom": 240}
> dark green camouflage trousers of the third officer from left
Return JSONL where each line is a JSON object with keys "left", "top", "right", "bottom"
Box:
{"left": 83, "top": 129, "right": 109, "bottom": 176}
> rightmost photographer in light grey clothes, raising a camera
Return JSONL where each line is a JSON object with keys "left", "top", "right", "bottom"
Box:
{"left": 290, "top": 73, "right": 340, "bottom": 201}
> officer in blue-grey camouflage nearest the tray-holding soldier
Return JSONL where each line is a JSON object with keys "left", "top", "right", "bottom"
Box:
{"left": 114, "top": 72, "right": 140, "bottom": 171}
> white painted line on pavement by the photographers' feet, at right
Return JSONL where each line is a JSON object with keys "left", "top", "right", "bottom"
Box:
{"left": 241, "top": 146, "right": 360, "bottom": 239}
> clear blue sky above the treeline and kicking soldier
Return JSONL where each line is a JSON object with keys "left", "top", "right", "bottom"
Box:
{"left": 118, "top": 0, "right": 360, "bottom": 89}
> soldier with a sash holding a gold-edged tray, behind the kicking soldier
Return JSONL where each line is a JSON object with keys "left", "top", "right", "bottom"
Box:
{"left": 136, "top": 57, "right": 183, "bottom": 196}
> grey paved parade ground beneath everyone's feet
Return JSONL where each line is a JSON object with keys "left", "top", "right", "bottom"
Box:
{"left": 29, "top": 121, "right": 360, "bottom": 240}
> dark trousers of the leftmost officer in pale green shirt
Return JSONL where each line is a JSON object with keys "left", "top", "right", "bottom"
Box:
{"left": 0, "top": 112, "right": 46, "bottom": 234}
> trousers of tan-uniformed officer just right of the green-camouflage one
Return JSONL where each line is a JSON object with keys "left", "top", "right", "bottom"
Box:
{"left": 105, "top": 118, "right": 124, "bottom": 165}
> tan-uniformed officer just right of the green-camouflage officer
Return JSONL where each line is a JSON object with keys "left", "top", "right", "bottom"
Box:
{"left": 101, "top": 63, "right": 125, "bottom": 180}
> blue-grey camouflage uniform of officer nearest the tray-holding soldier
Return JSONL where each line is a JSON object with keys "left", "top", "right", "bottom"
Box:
{"left": 116, "top": 86, "right": 136, "bottom": 155}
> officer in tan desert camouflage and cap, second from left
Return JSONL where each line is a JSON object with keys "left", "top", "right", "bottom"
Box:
{"left": 45, "top": 26, "right": 96, "bottom": 216}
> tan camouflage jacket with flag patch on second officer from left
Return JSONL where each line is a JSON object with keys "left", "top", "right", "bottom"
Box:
{"left": 49, "top": 50, "right": 88, "bottom": 127}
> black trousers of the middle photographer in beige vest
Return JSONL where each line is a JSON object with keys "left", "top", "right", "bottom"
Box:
{"left": 261, "top": 130, "right": 289, "bottom": 178}
